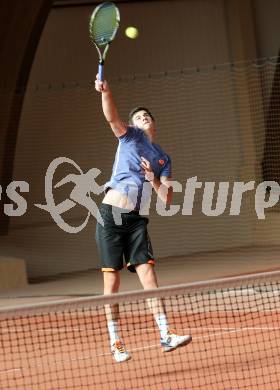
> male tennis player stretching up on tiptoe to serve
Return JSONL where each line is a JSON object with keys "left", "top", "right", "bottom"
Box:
{"left": 95, "top": 77, "right": 192, "bottom": 362}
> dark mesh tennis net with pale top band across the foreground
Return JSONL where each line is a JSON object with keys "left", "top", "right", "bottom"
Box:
{"left": 0, "top": 271, "right": 280, "bottom": 390}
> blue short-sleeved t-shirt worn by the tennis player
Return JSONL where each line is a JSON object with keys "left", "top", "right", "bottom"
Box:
{"left": 105, "top": 126, "right": 171, "bottom": 209}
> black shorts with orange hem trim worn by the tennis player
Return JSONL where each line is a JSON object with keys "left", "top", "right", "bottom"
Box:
{"left": 95, "top": 203, "right": 154, "bottom": 272}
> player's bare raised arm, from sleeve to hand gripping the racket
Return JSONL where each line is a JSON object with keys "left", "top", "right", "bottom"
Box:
{"left": 95, "top": 77, "right": 126, "bottom": 137}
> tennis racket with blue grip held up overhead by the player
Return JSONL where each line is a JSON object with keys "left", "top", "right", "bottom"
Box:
{"left": 89, "top": 2, "right": 120, "bottom": 81}
